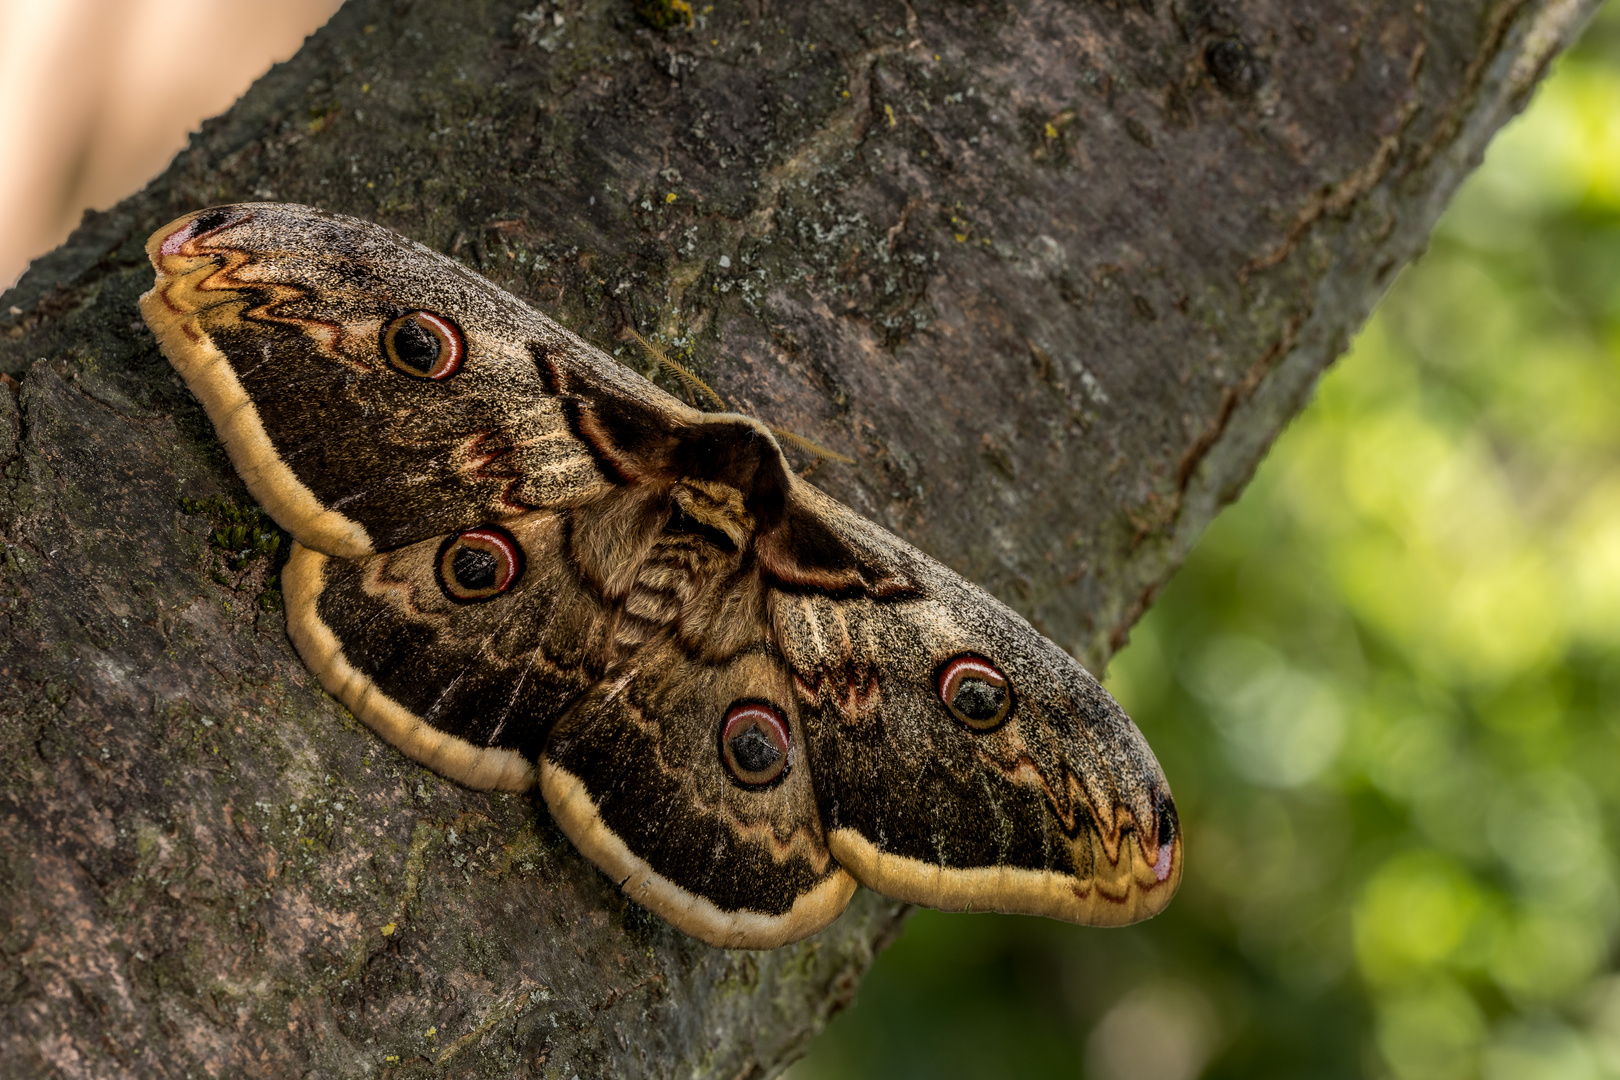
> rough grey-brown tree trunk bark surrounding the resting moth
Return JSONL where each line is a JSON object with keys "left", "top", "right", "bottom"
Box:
{"left": 0, "top": 0, "right": 1596, "bottom": 1080}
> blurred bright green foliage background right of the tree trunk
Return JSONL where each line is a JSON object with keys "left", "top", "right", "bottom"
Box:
{"left": 792, "top": 5, "right": 1620, "bottom": 1080}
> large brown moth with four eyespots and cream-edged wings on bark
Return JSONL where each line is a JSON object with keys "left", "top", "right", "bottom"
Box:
{"left": 141, "top": 204, "right": 1183, "bottom": 949}
